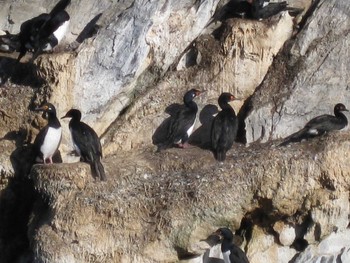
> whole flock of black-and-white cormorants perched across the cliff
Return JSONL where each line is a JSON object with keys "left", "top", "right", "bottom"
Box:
{"left": 0, "top": 0, "right": 348, "bottom": 263}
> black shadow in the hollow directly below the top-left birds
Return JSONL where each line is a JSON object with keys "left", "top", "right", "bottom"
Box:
{"left": 0, "top": 56, "right": 45, "bottom": 88}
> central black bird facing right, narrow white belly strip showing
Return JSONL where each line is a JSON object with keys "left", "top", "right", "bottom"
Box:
{"left": 157, "top": 89, "right": 201, "bottom": 151}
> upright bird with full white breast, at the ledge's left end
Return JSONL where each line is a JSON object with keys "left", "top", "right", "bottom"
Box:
{"left": 34, "top": 103, "right": 62, "bottom": 164}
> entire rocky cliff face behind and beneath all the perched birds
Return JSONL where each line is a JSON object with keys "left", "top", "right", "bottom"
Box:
{"left": 0, "top": 0, "right": 350, "bottom": 263}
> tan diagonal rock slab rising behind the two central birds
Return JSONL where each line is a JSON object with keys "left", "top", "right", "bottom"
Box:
{"left": 103, "top": 13, "right": 293, "bottom": 153}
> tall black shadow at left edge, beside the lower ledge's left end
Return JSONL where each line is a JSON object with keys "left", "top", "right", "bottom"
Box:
{"left": 0, "top": 124, "right": 62, "bottom": 262}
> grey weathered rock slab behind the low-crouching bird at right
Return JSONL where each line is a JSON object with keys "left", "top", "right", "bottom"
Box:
{"left": 245, "top": 0, "right": 350, "bottom": 143}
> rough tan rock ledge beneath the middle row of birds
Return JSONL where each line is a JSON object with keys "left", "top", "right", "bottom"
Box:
{"left": 31, "top": 132, "right": 350, "bottom": 263}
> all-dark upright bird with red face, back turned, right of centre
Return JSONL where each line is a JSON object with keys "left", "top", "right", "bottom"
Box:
{"left": 211, "top": 92, "right": 238, "bottom": 162}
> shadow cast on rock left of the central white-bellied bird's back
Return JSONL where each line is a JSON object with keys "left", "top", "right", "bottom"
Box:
{"left": 152, "top": 103, "right": 184, "bottom": 145}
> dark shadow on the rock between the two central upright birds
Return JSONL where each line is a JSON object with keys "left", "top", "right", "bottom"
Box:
{"left": 189, "top": 104, "right": 219, "bottom": 150}
